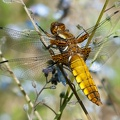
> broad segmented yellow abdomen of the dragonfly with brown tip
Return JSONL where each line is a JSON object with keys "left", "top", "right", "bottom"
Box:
{"left": 70, "top": 54, "right": 102, "bottom": 105}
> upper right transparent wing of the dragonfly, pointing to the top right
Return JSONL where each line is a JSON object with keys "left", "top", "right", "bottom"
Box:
{"left": 77, "top": 10, "right": 120, "bottom": 41}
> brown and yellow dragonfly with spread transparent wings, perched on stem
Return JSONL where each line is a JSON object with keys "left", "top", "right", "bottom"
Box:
{"left": 0, "top": 11, "right": 120, "bottom": 106}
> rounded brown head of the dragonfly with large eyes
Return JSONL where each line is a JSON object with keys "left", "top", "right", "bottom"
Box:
{"left": 50, "top": 22, "right": 65, "bottom": 35}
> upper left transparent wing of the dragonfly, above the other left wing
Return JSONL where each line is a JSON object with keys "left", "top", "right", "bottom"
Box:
{"left": 0, "top": 27, "right": 49, "bottom": 54}
